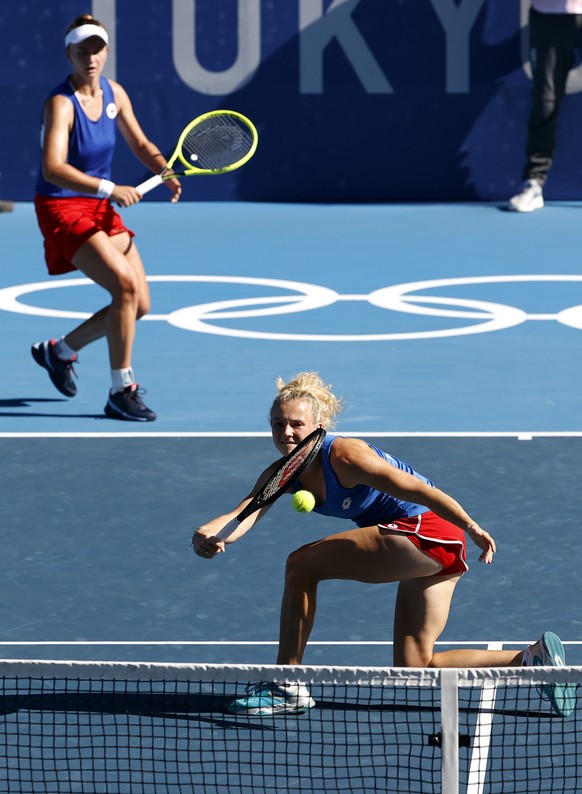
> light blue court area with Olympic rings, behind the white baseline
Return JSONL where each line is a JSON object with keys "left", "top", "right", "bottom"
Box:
{"left": 0, "top": 203, "right": 582, "bottom": 434}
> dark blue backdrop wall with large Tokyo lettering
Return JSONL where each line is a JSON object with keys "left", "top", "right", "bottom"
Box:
{"left": 0, "top": 0, "right": 582, "bottom": 202}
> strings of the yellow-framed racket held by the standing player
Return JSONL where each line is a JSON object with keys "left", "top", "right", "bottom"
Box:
{"left": 182, "top": 116, "right": 254, "bottom": 171}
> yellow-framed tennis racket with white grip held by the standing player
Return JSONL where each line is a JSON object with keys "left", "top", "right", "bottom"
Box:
{"left": 136, "top": 110, "right": 259, "bottom": 196}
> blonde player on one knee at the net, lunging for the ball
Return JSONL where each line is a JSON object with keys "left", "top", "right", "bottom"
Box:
{"left": 192, "top": 372, "right": 575, "bottom": 715}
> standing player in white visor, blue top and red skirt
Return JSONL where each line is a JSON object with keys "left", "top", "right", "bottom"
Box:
{"left": 32, "top": 14, "right": 180, "bottom": 422}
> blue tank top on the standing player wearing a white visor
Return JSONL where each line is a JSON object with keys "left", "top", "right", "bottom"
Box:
{"left": 36, "top": 77, "right": 117, "bottom": 198}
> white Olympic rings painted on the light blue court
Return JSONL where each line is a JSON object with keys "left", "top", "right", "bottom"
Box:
{"left": 0, "top": 275, "right": 582, "bottom": 342}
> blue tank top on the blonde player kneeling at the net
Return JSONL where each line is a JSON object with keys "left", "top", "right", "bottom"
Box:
{"left": 294, "top": 433, "right": 434, "bottom": 527}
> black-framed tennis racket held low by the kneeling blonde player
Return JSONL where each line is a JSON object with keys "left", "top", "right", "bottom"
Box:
{"left": 215, "top": 427, "right": 325, "bottom": 540}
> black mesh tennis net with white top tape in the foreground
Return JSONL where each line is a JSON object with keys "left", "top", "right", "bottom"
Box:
{"left": 0, "top": 661, "right": 582, "bottom": 794}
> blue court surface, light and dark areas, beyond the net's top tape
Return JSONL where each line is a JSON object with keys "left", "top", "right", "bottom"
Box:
{"left": 0, "top": 203, "right": 582, "bottom": 794}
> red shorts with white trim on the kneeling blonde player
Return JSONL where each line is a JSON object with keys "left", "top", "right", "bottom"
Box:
{"left": 380, "top": 511, "right": 469, "bottom": 576}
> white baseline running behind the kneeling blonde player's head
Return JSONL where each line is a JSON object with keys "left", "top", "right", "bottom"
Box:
{"left": 0, "top": 430, "right": 582, "bottom": 441}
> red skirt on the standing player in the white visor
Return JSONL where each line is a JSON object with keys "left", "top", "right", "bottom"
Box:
{"left": 34, "top": 193, "right": 135, "bottom": 276}
